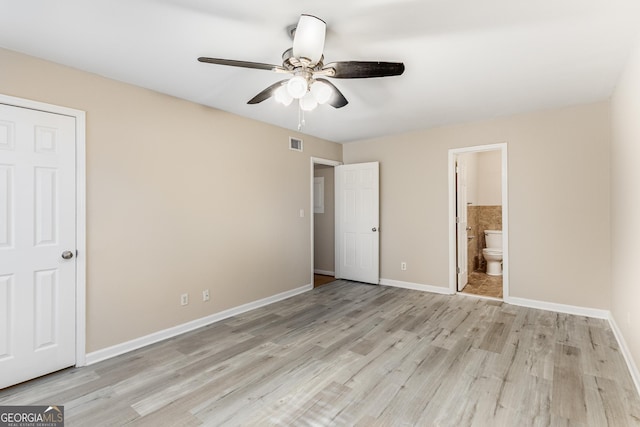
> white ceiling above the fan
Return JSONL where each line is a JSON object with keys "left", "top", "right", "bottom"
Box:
{"left": 0, "top": 0, "right": 640, "bottom": 142}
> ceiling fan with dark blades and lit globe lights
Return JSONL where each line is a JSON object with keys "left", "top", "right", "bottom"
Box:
{"left": 198, "top": 14, "right": 404, "bottom": 111}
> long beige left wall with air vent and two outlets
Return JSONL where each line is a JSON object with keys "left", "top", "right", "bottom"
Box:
{"left": 0, "top": 49, "right": 342, "bottom": 352}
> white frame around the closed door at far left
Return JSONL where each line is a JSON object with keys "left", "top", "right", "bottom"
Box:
{"left": 0, "top": 94, "right": 87, "bottom": 366}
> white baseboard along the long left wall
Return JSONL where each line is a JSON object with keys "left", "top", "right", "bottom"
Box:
{"left": 85, "top": 284, "right": 313, "bottom": 365}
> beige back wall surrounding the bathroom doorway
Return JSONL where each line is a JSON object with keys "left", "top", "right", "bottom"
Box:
{"left": 343, "top": 102, "right": 611, "bottom": 309}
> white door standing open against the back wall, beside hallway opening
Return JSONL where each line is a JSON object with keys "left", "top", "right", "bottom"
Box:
{"left": 335, "top": 162, "right": 380, "bottom": 285}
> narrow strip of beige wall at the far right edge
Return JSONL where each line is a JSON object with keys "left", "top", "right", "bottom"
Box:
{"left": 611, "top": 40, "right": 640, "bottom": 374}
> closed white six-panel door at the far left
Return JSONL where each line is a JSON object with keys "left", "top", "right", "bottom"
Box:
{"left": 0, "top": 104, "right": 76, "bottom": 388}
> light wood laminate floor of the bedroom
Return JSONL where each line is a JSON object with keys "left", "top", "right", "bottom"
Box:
{"left": 0, "top": 281, "right": 640, "bottom": 427}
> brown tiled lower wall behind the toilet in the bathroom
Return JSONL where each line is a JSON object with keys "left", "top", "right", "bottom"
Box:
{"left": 467, "top": 205, "right": 502, "bottom": 272}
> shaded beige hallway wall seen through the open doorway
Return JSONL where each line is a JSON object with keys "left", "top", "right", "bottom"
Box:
{"left": 313, "top": 165, "right": 335, "bottom": 272}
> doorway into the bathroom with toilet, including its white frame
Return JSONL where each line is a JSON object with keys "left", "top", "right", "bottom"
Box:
{"left": 449, "top": 143, "right": 509, "bottom": 299}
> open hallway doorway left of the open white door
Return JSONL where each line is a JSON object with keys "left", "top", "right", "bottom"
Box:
{"left": 311, "top": 158, "right": 341, "bottom": 288}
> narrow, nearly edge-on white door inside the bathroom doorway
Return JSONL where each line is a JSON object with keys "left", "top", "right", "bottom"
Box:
{"left": 456, "top": 156, "right": 469, "bottom": 291}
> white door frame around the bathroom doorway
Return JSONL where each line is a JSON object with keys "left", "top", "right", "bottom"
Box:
{"left": 448, "top": 142, "right": 509, "bottom": 300}
